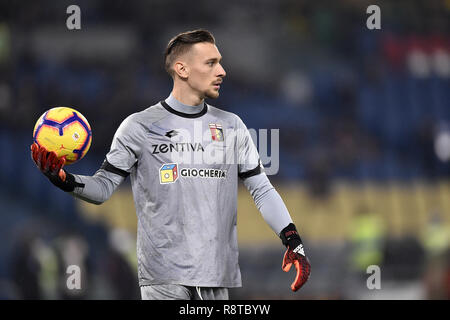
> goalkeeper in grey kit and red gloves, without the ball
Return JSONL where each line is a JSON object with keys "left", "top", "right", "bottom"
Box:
{"left": 31, "top": 30, "right": 310, "bottom": 300}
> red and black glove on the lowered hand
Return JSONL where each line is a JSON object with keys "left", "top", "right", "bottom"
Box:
{"left": 280, "top": 223, "right": 311, "bottom": 292}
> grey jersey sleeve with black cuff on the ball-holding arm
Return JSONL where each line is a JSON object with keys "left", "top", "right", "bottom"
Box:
{"left": 104, "top": 115, "right": 142, "bottom": 175}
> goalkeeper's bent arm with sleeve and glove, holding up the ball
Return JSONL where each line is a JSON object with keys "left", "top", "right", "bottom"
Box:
{"left": 31, "top": 115, "right": 142, "bottom": 204}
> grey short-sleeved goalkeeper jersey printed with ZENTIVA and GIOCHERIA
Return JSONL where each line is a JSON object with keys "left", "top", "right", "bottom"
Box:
{"left": 101, "top": 96, "right": 262, "bottom": 287}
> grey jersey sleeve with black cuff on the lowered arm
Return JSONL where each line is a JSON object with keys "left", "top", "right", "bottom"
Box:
{"left": 237, "top": 117, "right": 264, "bottom": 180}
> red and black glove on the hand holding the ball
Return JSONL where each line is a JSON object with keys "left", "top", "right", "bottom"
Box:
{"left": 31, "top": 143, "right": 84, "bottom": 192}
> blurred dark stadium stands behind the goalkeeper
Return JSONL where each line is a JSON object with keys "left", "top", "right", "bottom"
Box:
{"left": 0, "top": 0, "right": 450, "bottom": 299}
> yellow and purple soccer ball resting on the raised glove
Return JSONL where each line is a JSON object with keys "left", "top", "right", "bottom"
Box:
{"left": 33, "top": 107, "right": 92, "bottom": 164}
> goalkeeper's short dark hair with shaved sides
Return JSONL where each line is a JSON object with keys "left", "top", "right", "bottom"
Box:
{"left": 164, "top": 29, "right": 216, "bottom": 77}
